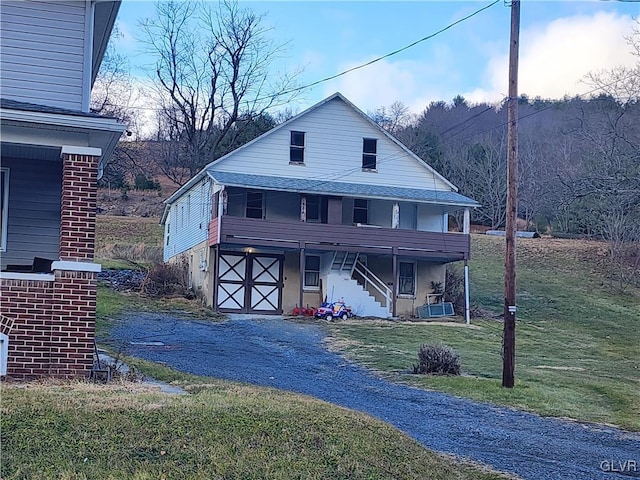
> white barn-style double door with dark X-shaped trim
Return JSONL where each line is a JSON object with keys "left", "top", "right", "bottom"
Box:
{"left": 216, "top": 252, "right": 284, "bottom": 314}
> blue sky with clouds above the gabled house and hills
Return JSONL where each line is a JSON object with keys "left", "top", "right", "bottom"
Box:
{"left": 116, "top": 0, "right": 640, "bottom": 127}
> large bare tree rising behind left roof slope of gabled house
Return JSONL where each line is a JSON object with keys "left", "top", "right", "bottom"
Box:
{"left": 142, "top": 0, "right": 296, "bottom": 183}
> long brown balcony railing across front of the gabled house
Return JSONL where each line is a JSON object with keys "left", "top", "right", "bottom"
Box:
{"left": 209, "top": 216, "right": 470, "bottom": 261}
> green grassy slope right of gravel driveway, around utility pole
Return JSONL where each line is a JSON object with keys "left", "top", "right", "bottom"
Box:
{"left": 330, "top": 235, "right": 640, "bottom": 430}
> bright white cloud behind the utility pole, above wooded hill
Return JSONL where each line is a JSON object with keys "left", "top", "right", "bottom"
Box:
{"left": 464, "top": 12, "right": 637, "bottom": 102}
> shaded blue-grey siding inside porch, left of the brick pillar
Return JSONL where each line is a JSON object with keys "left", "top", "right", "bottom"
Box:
{"left": 0, "top": 157, "right": 62, "bottom": 269}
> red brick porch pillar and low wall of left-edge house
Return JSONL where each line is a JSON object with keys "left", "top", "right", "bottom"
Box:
{"left": 0, "top": 154, "right": 98, "bottom": 379}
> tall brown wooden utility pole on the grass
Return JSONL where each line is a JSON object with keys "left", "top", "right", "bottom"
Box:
{"left": 502, "top": 0, "right": 520, "bottom": 388}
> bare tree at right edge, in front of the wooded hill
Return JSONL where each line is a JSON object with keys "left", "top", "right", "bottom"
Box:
{"left": 570, "top": 19, "right": 640, "bottom": 290}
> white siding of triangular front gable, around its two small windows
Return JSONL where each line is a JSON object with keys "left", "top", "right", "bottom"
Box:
{"left": 210, "top": 98, "right": 451, "bottom": 190}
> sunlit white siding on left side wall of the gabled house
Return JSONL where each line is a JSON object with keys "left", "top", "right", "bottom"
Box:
{"left": 164, "top": 179, "right": 211, "bottom": 261}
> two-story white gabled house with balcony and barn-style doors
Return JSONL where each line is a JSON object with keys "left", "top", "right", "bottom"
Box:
{"left": 162, "top": 93, "right": 478, "bottom": 317}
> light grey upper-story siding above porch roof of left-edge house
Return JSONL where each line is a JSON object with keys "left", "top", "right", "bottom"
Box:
{"left": 0, "top": 0, "right": 89, "bottom": 111}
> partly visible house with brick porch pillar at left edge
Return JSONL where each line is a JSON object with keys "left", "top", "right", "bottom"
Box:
{"left": 0, "top": 0, "right": 125, "bottom": 378}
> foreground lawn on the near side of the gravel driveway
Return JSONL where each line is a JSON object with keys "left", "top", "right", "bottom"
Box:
{"left": 0, "top": 376, "right": 506, "bottom": 480}
